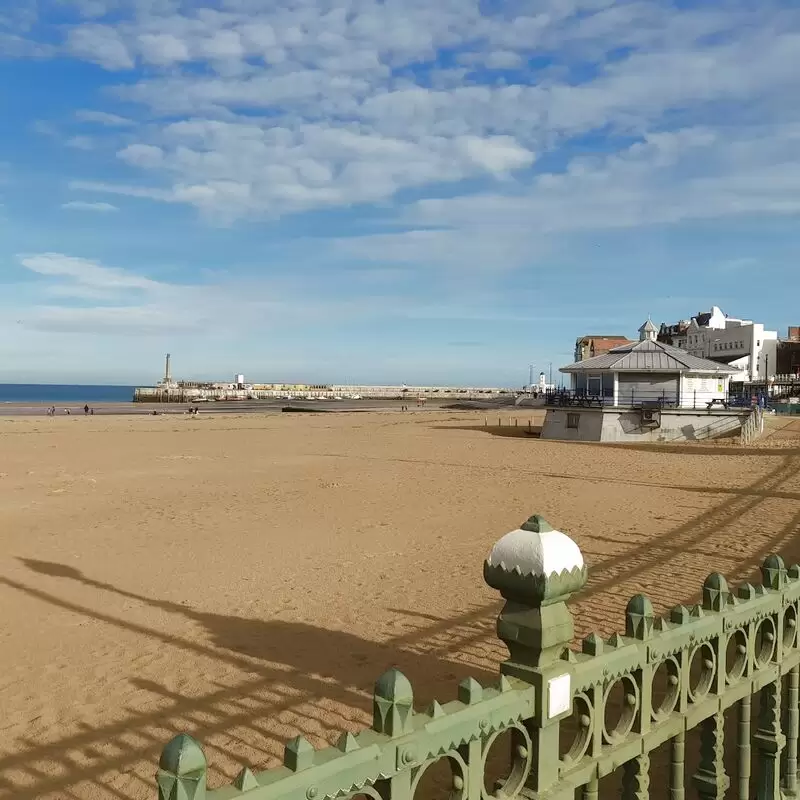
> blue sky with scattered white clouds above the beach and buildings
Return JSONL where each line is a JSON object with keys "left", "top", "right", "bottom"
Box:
{"left": 0, "top": 0, "right": 800, "bottom": 386}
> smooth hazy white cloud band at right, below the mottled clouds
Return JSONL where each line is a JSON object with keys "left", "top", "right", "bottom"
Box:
{"left": 337, "top": 124, "right": 800, "bottom": 269}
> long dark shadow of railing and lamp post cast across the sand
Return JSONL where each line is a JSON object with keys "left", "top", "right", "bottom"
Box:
{"left": 6, "top": 451, "right": 800, "bottom": 800}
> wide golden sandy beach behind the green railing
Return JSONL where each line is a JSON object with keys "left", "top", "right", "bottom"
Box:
{"left": 0, "top": 411, "right": 800, "bottom": 800}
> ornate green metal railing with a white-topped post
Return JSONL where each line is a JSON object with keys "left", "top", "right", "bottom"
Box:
{"left": 157, "top": 517, "right": 800, "bottom": 800}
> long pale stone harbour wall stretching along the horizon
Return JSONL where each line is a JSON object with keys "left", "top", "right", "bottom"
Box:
{"left": 133, "top": 384, "right": 514, "bottom": 403}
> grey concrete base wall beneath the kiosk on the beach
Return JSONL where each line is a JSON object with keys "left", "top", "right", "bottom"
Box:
{"left": 542, "top": 407, "right": 749, "bottom": 442}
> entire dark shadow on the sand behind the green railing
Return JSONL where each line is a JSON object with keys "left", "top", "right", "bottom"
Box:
{"left": 0, "top": 451, "right": 800, "bottom": 800}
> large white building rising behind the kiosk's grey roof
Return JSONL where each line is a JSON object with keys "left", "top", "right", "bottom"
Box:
{"left": 658, "top": 306, "right": 778, "bottom": 381}
